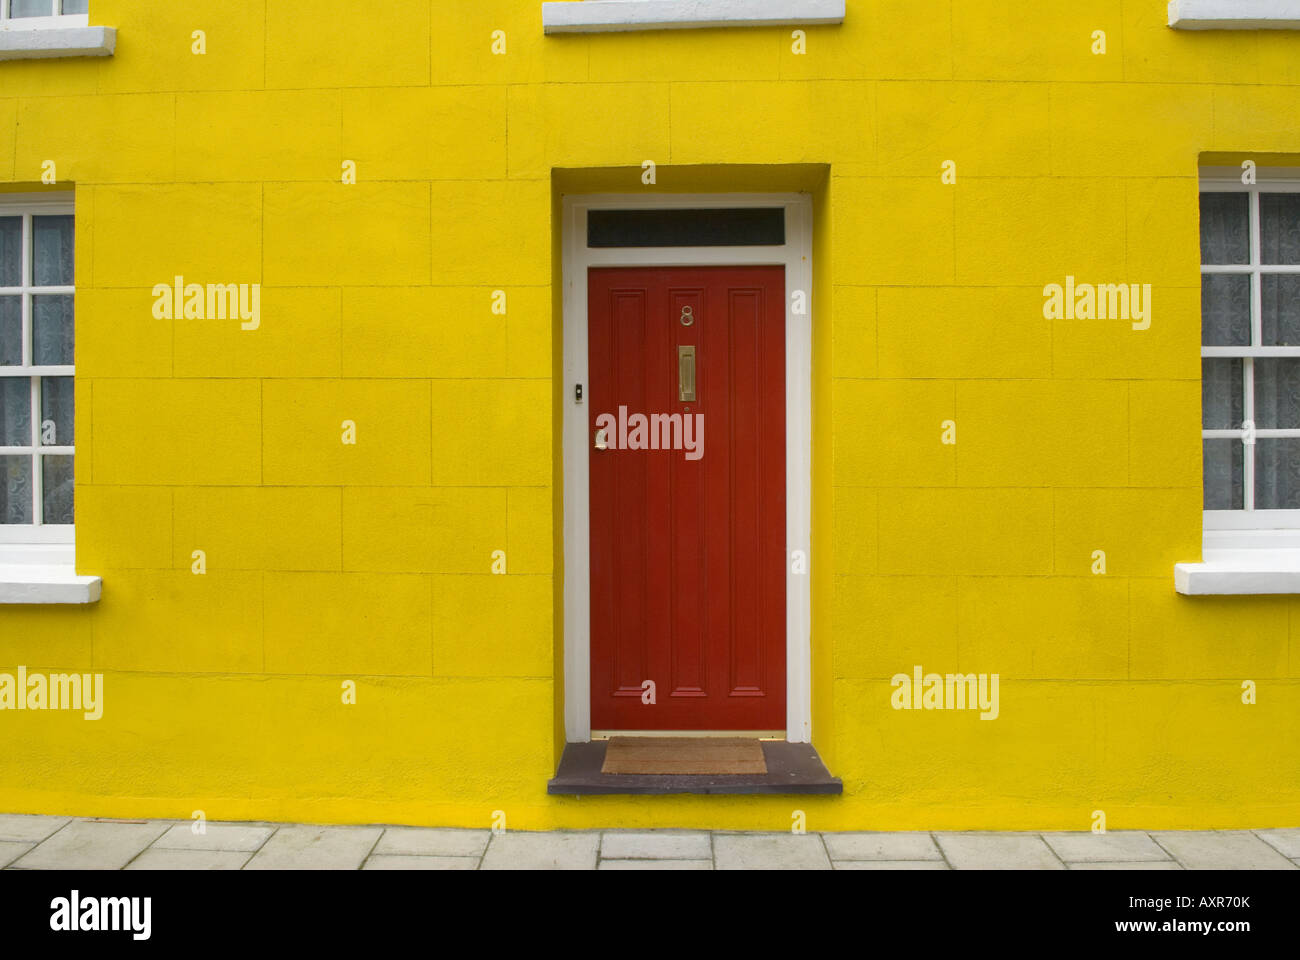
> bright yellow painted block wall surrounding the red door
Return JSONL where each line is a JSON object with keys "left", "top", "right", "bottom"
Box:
{"left": 0, "top": 0, "right": 1300, "bottom": 830}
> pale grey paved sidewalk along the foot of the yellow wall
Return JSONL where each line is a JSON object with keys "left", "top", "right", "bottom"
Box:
{"left": 0, "top": 816, "right": 1300, "bottom": 870}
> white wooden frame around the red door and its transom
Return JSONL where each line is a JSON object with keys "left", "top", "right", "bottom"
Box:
{"left": 560, "top": 194, "right": 813, "bottom": 743}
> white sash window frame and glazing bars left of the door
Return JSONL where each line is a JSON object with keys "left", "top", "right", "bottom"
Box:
{"left": 0, "top": 194, "right": 77, "bottom": 546}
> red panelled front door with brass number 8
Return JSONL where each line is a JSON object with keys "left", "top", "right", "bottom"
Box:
{"left": 588, "top": 267, "right": 787, "bottom": 730}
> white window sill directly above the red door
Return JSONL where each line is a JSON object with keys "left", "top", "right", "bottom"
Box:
{"left": 542, "top": 0, "right": 845, "bottom": 34}
